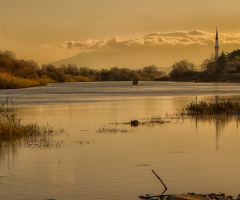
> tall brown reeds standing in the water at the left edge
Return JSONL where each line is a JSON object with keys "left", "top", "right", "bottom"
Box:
{"left": 0, "top": 99, "right": 60, "bottom": 146}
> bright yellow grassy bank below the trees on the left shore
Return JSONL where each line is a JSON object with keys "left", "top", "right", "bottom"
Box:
{"left": 0, "top": 73, "right": 54, "bottom": 89}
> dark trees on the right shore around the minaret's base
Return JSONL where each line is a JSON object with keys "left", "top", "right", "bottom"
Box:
{"left": 173, "top": 49, "right": 240, "bottom": 82}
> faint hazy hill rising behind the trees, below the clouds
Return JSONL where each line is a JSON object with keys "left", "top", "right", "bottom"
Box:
{"left": 52, "top": 46, "right": 209, "bottom": 71}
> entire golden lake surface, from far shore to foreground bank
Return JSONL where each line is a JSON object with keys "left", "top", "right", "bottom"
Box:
{"left": 0, "top": 82, "right": 240, "bottom": 200}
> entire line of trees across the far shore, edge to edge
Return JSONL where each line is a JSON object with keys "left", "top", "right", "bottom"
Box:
{"left": 0, "top": 49, "right": 240, "bottom": 88}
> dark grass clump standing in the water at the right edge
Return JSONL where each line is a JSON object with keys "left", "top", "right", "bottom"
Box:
{"left": 184, "top": 100, "right": 240, "bottom": 115}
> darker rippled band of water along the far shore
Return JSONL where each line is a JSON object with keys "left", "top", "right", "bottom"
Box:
{"left": 0, "top": 82, "right": 240, "bottom": 105}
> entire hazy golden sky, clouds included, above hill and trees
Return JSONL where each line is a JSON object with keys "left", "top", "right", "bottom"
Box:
{"left": 0, "top": 0, "right": 240, "bottom": 68}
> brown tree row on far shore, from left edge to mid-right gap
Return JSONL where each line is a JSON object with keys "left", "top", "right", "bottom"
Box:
{"left": 0, "top": 51, "right": 166, "bottom": 82}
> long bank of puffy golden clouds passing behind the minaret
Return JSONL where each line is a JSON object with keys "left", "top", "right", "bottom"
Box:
{"left": 60, "top": 30, "right": 240, "bottom": 50}
